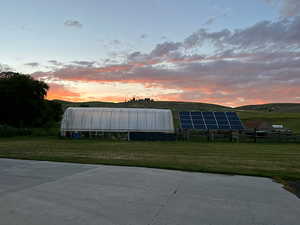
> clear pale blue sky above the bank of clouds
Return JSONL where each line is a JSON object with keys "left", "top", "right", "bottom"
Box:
{"left": 0, "top": 0, "right": 278, "bottom": 67}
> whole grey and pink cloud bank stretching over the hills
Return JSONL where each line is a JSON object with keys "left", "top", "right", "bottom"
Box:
{"left": 32, "top": 17, "right": 300, "bottom": 106}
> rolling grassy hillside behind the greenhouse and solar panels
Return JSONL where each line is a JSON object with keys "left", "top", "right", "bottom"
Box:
{"left": 55, "top": 100, "right": 300, "bottom": 132}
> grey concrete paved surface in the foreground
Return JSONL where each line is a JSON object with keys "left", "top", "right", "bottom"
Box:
{"left": 0, "top": 159, "right": 300, "bottom": 225}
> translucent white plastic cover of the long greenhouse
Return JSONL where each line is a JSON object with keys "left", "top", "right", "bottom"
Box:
{"left": 61, "top": 107, "right": 174, "bottom": 133}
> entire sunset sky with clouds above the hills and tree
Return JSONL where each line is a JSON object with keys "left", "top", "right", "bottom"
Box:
{"left": 0, "top": 0, "right": 300, "bottom": 106}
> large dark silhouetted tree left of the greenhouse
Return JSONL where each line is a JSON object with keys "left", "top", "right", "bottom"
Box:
{"left": 0, "top": 72, "right": 59, "bottom": 127}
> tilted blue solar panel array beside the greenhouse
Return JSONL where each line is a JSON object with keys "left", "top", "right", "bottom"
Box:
{"left": 179, "top": 112, "right": 244, "bottom": 130}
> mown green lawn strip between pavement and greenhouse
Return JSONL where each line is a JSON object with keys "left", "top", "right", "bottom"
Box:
{"left": 0, "top": 137, "right": 300, "bottom": 180}
